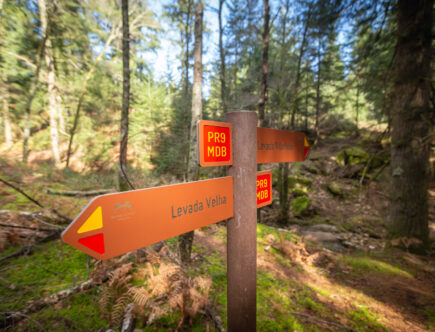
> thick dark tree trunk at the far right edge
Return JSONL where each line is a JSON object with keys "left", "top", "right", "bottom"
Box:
{"left": 389, "top": 0, "right": 433, "bottom": 252}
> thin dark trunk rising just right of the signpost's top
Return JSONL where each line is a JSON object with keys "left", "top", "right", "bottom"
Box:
{"left": 258, "top": 0, "right": 270, "bottom": 126}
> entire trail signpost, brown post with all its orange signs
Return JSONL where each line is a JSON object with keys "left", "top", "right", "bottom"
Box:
{"left": 62, "top": 111, "right": 309, "bottom": 331}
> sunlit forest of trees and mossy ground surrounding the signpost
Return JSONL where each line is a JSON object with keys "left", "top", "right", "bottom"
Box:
{"left": 0, "top": 0, "right": 435, "bottom": 332}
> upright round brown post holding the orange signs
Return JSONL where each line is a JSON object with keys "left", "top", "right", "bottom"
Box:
{"left": 226, "top": 111, "right": 257, "bottom": 332}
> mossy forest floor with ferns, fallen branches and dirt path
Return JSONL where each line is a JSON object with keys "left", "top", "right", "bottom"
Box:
{"left": 0, "top": 128, "right": 435, "bottom": 332}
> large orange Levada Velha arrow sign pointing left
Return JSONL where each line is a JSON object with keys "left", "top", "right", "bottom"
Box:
{"left": 62, "top": 176, "right": 233, "bottom": 259}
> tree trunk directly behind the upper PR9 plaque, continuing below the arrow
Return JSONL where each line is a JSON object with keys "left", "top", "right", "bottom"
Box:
{"left": 179, "top": 0, "right": 204, "bottom": 263}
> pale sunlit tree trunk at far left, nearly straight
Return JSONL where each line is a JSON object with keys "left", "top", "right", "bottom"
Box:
{"left": 38, "top": 0, "right": 60, "bottom": 166}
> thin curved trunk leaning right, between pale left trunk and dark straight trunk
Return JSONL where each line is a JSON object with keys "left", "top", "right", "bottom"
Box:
{"left": 65, "top": 26, "right": 119, "bottom": 168}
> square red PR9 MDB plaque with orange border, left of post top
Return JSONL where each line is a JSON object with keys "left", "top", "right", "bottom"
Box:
{"left": 198, "top": 120, "right": 233, "bottom": 167}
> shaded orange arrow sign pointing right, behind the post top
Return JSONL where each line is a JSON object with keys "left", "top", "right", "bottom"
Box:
{"left": 257, "top": 128, "right": 310, "bottom": 164}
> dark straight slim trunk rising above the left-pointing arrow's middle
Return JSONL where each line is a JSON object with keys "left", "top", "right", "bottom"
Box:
{"left": 118, "top": 0, "right": 130, "bottom": 191}
